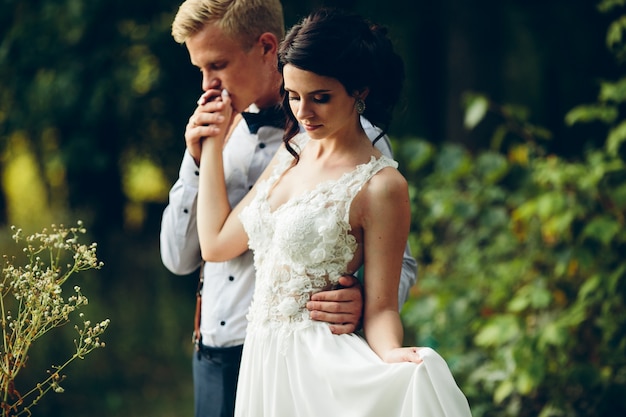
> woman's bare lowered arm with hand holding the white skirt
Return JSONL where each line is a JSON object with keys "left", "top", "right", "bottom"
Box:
{"left": 360, "top": 169, "right": 421, "bottom": 362}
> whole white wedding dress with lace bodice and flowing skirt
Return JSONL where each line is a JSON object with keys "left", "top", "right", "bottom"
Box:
{"left": 235, "top": 134, "right": 471, "bottom": 417}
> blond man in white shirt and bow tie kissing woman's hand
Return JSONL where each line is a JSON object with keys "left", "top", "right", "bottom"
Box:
{"left": 160, "top": 0, "right": 417, "bottom": 417}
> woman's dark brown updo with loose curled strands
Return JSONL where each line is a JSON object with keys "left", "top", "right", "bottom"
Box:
{"left": 278, "top": 8, "right": 404, "bottom": 161}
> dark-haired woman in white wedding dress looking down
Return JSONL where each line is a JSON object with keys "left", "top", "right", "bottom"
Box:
{"left": 198, "top": 9, "right": 471, "bottom": 417}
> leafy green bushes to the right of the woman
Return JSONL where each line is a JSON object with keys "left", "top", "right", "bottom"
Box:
{"left": 398, "top": 1, "right": 626, "bottom": 417}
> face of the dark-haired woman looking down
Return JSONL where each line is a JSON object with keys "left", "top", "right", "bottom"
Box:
{"left": 283, "top": 64, "right": 359, "bottom": 139}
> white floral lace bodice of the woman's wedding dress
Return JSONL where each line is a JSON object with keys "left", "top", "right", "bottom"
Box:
{"left": 240, "top": 134, "right": 397, "bottom": 342}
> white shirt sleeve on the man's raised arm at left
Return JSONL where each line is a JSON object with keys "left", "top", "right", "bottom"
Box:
{"left": 160, "top": 151, "right": 202, "bottom": 275}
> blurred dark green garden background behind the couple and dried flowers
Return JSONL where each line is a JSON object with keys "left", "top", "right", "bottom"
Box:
{"left": 0, "top": 0, "right": 626, "bottom": 417}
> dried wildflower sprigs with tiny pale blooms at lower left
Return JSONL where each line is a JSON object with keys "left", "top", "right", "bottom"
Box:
{"left": 0, "top": 222, "right": 109, "bottom": 417}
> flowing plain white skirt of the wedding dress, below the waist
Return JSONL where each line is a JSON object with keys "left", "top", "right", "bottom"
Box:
{"left": 235, "top": 322, "right": 471, "bottom": 417}
